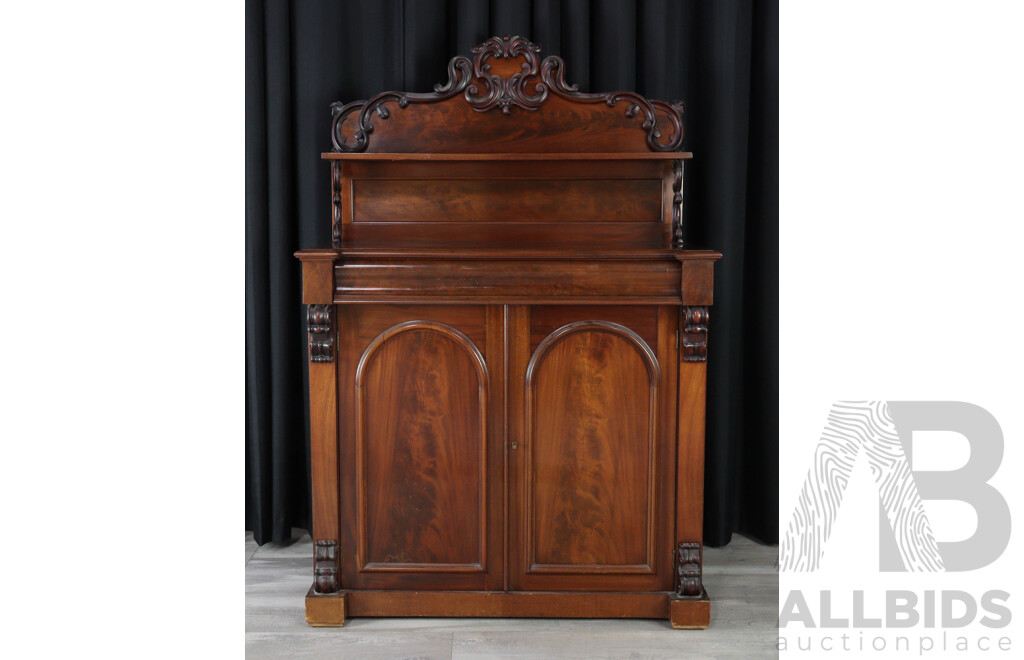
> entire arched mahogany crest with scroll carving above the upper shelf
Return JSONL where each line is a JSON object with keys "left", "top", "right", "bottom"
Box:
{"left": 331, "top": 35, "right": 683, "bottom": 153}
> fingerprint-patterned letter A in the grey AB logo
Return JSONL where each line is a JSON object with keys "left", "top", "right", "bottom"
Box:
{"left": 779, "top": 401, "right": 944, "bottom": 572}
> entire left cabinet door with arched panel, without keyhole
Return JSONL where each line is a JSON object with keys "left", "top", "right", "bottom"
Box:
{"left": 338, "top": 305, "right": 504, "bottom": 589}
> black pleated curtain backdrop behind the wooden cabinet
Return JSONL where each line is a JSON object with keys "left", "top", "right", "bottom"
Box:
{"left": 246, "top": 0, "right": 778, "bottom": 545}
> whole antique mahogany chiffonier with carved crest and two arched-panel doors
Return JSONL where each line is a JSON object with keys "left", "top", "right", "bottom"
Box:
{"left": 297, "top": 36, "right": 721, "bottom": 628}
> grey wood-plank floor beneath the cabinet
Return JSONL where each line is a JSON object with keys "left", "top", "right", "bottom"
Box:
{"left": 246, "top": 533, "right": 778, "bottom": 660}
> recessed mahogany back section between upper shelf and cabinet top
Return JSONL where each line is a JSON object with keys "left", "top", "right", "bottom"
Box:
{"left": 332, "top": 159, "right": 679, "bottom": 249}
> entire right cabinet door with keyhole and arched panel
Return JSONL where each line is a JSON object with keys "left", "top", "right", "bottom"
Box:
{"left": 509, "top": 306, "right": 679, "bottom": 590}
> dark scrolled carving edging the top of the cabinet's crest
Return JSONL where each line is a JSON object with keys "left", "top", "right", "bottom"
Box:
{"left": 331, "top": 35, "right": 683, "bottom": 151}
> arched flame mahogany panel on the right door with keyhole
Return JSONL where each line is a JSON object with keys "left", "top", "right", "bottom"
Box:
{"left": 523, "top": 323, "right": 660, "bottom": 573}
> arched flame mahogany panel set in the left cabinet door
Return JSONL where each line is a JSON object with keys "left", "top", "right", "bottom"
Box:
{"left": 356, "top": 321, "right": 487, "bottom": 571}
